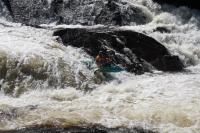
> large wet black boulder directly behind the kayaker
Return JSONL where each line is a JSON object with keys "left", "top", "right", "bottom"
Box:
{"left": 54, "top": 27, "right": 183, "bottom": 74}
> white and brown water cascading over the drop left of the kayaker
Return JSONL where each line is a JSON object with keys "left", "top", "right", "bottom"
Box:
{"left": 0, "top": 24, "right": 100, "bottom": 97}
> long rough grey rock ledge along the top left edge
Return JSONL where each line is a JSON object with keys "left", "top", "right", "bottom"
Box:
{"left": 3, "top": 0, "right": 152, "bottom": 25}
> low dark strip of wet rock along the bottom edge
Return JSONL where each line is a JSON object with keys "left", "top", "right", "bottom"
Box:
{"left": 4, "top": 125, "right": 156, "bottom": 133}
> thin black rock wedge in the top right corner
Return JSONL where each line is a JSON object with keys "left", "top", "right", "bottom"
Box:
{"left": 153, "top": 0, "right": 200, "bottom": 9}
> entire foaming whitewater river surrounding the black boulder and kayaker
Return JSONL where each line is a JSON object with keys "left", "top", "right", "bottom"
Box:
{"left": 0, "top": 0, "right": 200, "bottom": 133}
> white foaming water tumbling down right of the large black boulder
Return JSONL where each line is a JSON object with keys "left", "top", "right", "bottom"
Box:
{"left": 122, "top": 2, "right": 200, "bottom": 66}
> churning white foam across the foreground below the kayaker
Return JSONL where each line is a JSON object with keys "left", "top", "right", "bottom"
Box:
{"left": 1, "top": 68, "right": 200, "bottom": 132}
